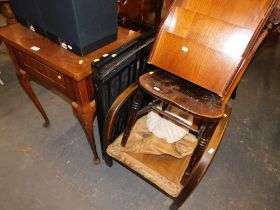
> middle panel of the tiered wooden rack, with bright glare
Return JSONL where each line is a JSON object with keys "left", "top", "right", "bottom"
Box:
{"left": 162, "top": 7, "right": 254, "bottom": 57}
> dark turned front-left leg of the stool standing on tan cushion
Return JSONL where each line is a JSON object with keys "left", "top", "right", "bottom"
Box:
{"left": 121, "top": 89, "right": 143, "bottom": 146}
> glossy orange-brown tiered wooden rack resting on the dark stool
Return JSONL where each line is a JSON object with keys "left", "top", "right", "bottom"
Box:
{"left": 149, "top": 0, "right": 277, "bottom": 97}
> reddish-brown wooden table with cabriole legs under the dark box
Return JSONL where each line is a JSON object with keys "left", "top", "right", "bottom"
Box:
{"left": 0, "top": 24, "right": 139, "bottom": 164}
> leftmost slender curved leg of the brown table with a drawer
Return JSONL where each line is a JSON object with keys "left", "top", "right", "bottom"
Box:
{"left": 16, "top": 69, "right": 50, "bottom": 127}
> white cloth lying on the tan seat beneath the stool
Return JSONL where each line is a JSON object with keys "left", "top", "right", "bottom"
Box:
{"left": 147, "top": 107, "right": 192, "bottom": 143}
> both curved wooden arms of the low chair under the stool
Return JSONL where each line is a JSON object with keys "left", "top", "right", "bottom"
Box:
{"left": 103, "top": 83, "right": 231, "bottom": 210}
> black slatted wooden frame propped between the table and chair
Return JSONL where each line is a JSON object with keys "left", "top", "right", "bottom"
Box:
{"left": 92, "top": 29, "right": 156, "bottom": 156}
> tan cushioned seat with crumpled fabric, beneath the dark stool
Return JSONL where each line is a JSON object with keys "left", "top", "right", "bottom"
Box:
{"left": 107, "top": 115, "right": 197, "bottom": 197}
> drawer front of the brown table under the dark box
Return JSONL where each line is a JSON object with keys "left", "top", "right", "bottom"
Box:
{"left": 19, "top": 53, "right": 65, "bottom": 88}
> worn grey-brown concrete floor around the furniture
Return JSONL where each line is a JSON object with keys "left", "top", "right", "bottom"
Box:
{"left": 0, "top": 18, "right": 280, "bottom": 210}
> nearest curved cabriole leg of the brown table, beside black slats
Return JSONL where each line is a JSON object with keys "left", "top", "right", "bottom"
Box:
{"left": 72, "top": 101, "right": 100, "bottom": 165}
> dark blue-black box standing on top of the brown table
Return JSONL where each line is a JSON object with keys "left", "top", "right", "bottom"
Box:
{"left": 9, "top": 0, "right": 118, "bottom": 56}
